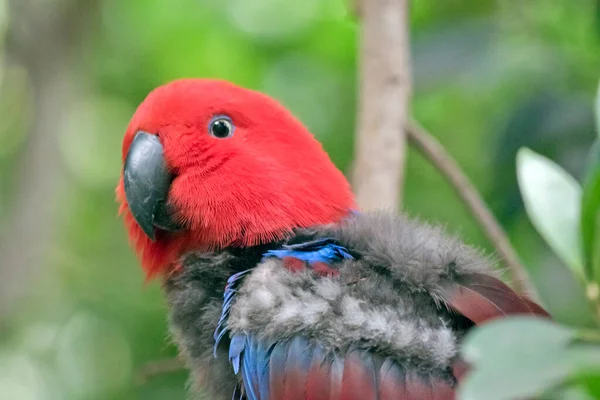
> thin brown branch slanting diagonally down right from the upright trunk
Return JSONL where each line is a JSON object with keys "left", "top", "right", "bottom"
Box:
{"left": 406, "top": 120, "right": 535, "bottom": 296}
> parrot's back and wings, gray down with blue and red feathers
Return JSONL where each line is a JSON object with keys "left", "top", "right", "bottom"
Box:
{"left": 215, "top": 214, "right": 547, "bottom": 400}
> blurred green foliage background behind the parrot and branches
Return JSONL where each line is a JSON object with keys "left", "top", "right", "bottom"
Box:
{"left": 0, "top": 0, "right": 600, "bottom": 400}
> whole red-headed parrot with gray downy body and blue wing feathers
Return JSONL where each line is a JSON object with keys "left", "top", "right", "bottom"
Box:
{"left": 116, "top": 78, "right": 550, "bottom": 400}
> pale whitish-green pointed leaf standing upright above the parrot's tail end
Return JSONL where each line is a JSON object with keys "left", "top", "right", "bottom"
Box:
{"left": 517, "top": 148, "right": 584, "bottom": 278}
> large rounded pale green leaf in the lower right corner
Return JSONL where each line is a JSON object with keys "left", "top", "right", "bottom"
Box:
{"left": 459, "top": 317, "right": 600, "bottom": 400}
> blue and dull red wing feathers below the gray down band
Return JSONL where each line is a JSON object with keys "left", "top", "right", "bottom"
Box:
{"left": 230, "top": 335, "right": 454, "bottom": 400}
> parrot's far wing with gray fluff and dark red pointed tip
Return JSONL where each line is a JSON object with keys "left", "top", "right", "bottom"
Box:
{"left": 298, "top": 213, "right": 549, "bottom": 325}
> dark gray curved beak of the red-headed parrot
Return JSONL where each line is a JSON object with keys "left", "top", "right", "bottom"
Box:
{"left": 123, "top": 131, "right": 182, "bottom": 240}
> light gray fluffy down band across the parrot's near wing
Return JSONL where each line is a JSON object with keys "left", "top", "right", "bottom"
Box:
{"left": 229, "top": 260, "right": 456, "bottom": 368}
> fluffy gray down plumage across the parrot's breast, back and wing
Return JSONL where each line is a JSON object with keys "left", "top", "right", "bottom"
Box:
{"left": 165, "top": 213, "right": 493, "bottom": 398}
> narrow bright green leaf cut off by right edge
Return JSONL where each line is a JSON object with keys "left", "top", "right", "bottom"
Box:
{"left": 581, "top": 139, "right": 600, "bottom": 282}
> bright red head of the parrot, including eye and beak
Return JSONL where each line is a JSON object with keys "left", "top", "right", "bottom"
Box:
{"left": 117, "top": 79, "right": 354, "bottom": 277}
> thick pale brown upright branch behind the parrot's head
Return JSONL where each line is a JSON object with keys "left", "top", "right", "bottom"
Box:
{"left": 353, "top": 0, "right": 411, "bottom": 210}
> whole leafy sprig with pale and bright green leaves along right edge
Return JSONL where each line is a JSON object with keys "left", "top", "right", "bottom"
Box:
{"left": 460, "top": 134, "right": 600, "bottom": 400}
